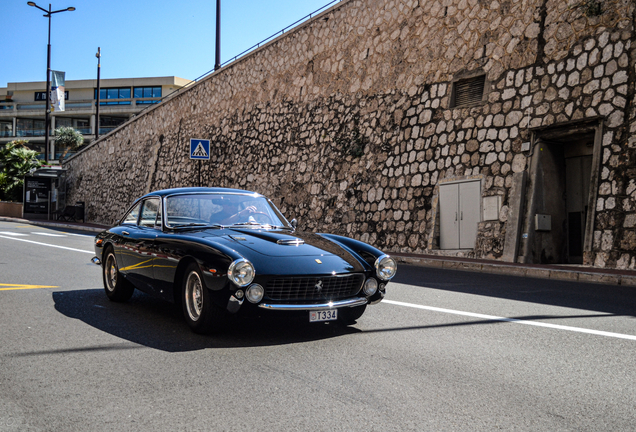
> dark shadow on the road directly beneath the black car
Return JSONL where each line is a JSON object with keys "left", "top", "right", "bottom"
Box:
{"left": 53, "top": 289, "right": 360, "bottom": 352}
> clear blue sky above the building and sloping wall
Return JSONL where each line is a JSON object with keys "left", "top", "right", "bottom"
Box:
{"left": 0, "top": 0, "right": 338, "bottom": 87}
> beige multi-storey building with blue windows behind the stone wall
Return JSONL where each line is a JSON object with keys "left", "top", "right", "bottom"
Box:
{"left": 0, "top": 76, "right": 191, "bottom": 160}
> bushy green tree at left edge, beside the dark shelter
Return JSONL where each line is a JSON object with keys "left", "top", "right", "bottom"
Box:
{"left": 0, "top": 140, "right": 42, "bottom": 202}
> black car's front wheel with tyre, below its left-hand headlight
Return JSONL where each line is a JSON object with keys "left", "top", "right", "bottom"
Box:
{"left": 181, "top": 263, "right": 226, "bottom": 334}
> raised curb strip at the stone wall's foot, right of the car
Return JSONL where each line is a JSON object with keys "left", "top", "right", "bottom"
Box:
{"left": 392, "top": 254, "right": 636, "bottom": 287}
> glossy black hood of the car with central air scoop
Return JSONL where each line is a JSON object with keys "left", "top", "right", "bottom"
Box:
{"left": 192, "top": 228, "right": 365, "bottom": 271}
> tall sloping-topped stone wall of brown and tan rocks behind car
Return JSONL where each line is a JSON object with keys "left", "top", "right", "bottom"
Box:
{"left": 66, "top": 0, "right": 636, "bottom": 268}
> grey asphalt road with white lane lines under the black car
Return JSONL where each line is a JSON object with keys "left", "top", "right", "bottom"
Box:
{"left": 0, "top": 222, "right": 636, "bottom": 432}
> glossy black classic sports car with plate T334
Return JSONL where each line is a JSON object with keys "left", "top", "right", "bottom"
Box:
{"left": 93, "top": 188, "right": 397, "bottom": 333}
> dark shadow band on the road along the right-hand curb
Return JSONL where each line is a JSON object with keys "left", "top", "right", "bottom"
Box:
{"left": 393, "top": 265, "right": 636, "bottom": 317}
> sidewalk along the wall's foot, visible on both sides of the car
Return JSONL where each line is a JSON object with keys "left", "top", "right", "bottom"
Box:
{"left": 0, "top": 216, "right": 636, "bottom": 287}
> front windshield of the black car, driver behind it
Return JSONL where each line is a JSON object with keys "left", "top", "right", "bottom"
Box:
{"left": 165, "top": 193, "right": 291, "bottom": 228}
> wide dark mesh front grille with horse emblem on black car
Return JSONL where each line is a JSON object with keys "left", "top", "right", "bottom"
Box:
{"left": 265, "top": 274, "right": 364, "bottom": 300}
